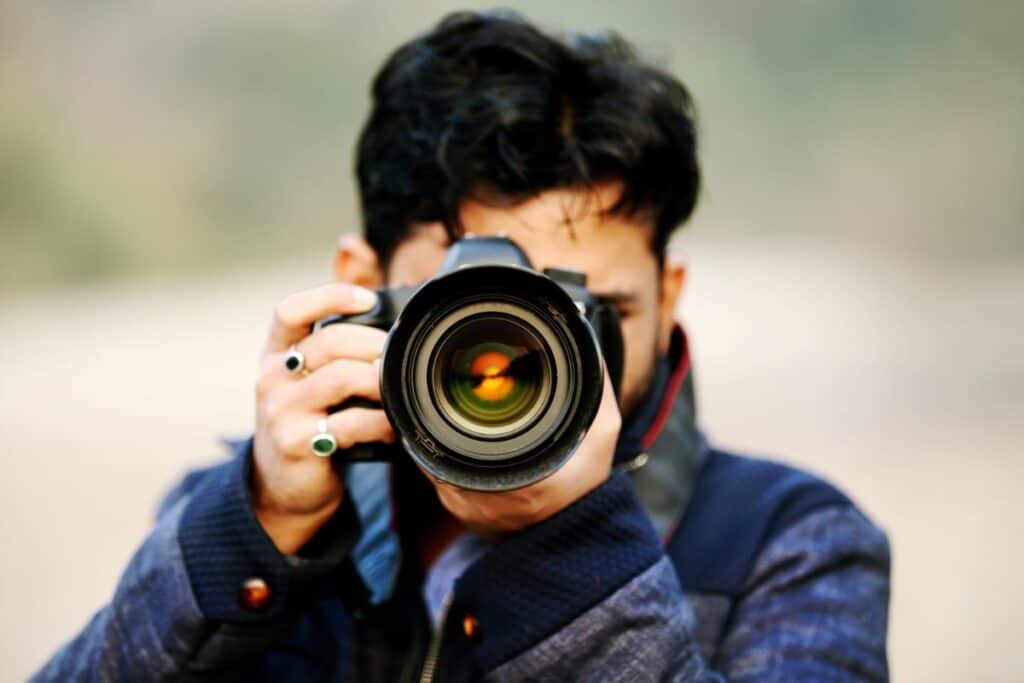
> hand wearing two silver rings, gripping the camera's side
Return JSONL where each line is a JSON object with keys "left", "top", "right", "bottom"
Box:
{"left": 252, "top": 283, "right": 394, "bottom": 553}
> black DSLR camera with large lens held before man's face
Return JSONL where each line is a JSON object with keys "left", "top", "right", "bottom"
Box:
{"left": 313, "top": 237, "right": 623, "bottom": 490}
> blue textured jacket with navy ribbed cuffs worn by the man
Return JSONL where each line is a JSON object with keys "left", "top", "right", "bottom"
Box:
{"left": 34, "top": 333, "right": 890, "bottom": 682}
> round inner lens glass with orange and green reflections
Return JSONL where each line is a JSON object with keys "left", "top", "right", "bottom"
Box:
{"left": 434, "top": 314, "right": 551, "bottom": 438}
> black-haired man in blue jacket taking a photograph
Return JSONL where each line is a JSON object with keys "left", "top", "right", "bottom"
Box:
{"left": 38, "top": 13, "right": 889, "bottom": 681}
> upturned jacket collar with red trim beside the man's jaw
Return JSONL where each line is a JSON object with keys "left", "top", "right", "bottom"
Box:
{"left": 614, "top": 326, "right": 707, "bottom": 538}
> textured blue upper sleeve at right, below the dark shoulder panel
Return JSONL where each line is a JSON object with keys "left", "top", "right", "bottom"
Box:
{"left": 716, "top": 506, "right": 890, "bottom": 681}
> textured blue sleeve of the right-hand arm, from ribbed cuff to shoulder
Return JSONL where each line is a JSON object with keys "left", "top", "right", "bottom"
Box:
{"left": 487, "top": 506, "right": 889, "bottom": 683}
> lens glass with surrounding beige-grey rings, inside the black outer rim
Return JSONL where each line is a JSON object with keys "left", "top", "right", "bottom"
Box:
{"left": 403, "top": 296, "right": 577, "bottom": 467}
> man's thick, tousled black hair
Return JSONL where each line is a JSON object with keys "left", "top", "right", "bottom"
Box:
{"left": 356, "top": 11, "right": 700, "bottom": 265}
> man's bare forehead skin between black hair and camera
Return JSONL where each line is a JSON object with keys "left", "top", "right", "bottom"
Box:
{"left": 389, "top": 183, "right": 657, "bottom": 291}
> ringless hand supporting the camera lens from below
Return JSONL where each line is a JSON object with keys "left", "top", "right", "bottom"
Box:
{"left": 427, "top": 374, "right": 622, "bottom": 539}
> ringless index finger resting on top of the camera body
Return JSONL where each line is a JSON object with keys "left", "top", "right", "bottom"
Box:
{"left": 266, "top": 283, "right": 377, "bottom": 352}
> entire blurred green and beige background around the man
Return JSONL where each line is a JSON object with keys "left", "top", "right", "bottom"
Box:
{"left": 0, "top": 0, "right": 1024, "bottom": 682}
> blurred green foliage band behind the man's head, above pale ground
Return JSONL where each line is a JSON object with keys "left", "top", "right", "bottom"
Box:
{"left": 0, "top": 0, "right": 1024, "bottom": 293}
